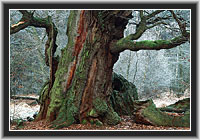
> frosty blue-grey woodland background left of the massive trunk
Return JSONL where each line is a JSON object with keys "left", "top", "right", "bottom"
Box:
{"left": 10, "top": 10, "right": 69, "bottom": 94}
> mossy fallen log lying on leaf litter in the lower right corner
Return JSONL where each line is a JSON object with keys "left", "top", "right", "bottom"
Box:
{"left": 134, "top": 100, "right": 190, "bottom": 127}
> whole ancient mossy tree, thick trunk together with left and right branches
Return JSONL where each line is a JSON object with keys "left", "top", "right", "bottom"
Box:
{"left": 10, "top": 10, "right": 190, "bottom": 126}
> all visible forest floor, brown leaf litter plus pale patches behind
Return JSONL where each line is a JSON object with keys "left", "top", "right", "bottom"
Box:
{"left": 10, "top": 93, "right": 190, "bottom": 130}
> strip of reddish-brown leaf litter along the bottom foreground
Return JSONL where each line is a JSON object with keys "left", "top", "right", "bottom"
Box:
{"left": 10, "top": 116, "right": 190, "bottom": 130}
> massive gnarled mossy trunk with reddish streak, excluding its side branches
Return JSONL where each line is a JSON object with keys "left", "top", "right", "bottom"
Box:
{"left": 38, "top": 11, "right": 134, "bottom": 126}
